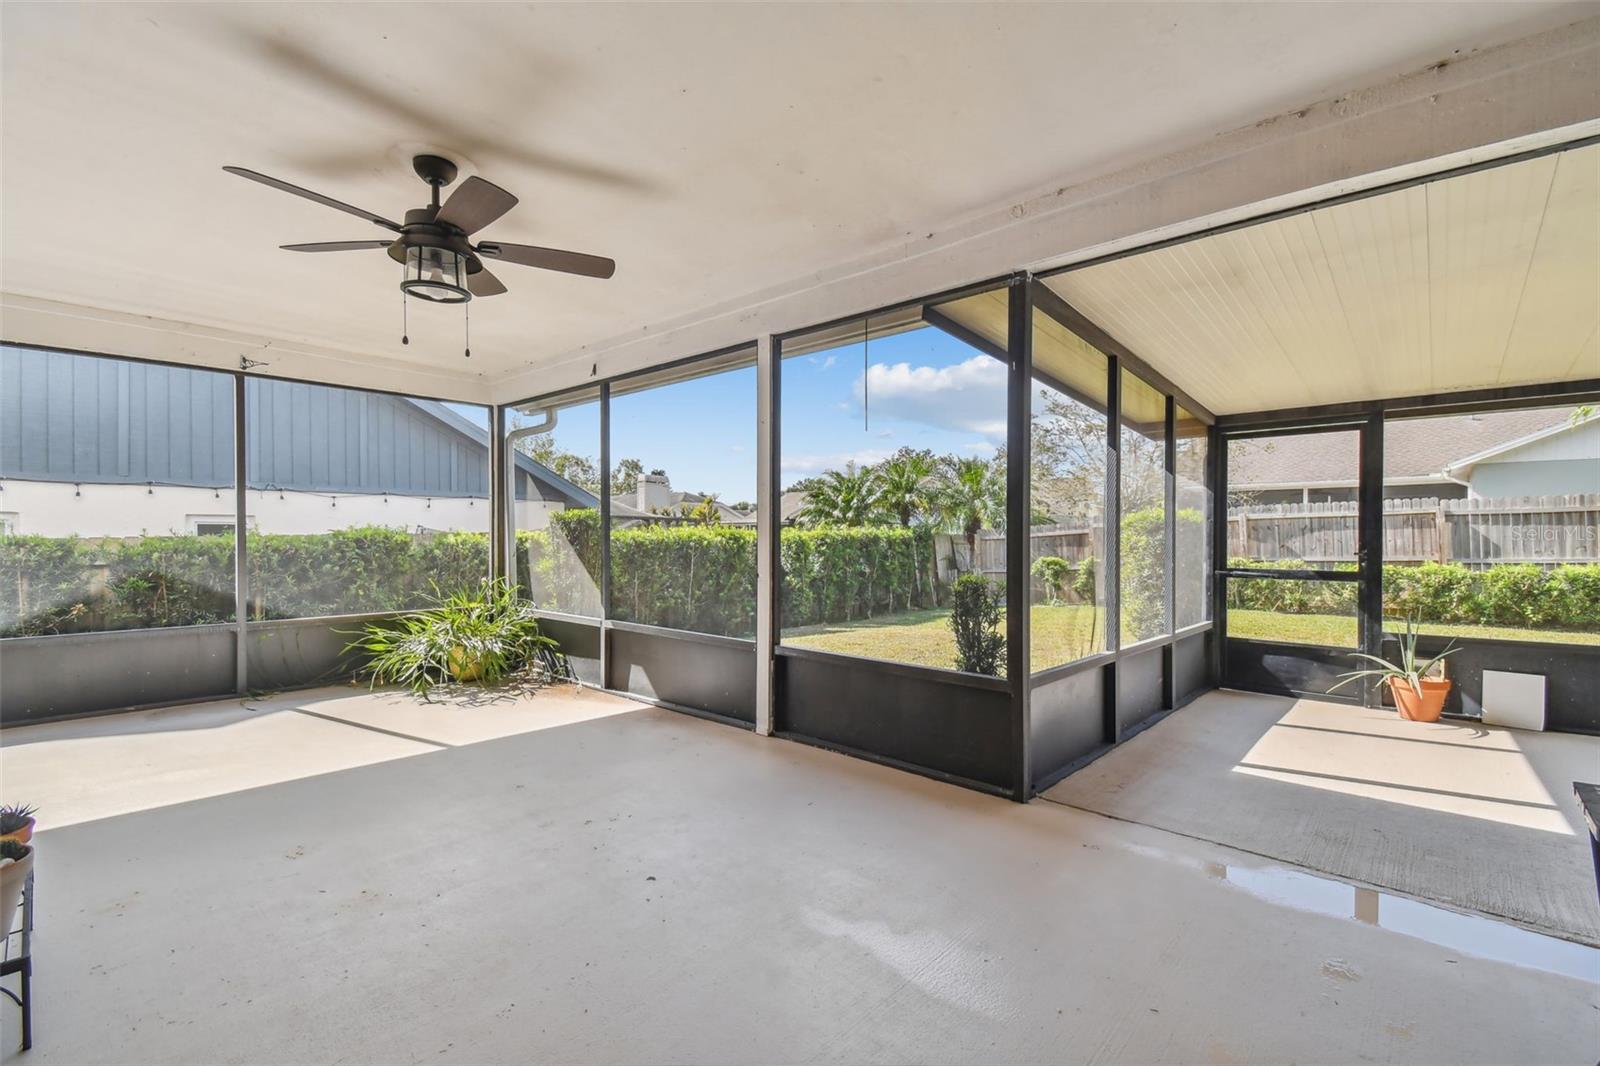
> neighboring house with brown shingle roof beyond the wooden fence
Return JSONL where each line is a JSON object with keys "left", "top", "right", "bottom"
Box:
{"left": 1227, "top": 408, "right": 1600, "bottom": 504}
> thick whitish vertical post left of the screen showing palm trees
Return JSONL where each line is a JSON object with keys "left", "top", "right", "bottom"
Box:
{"left": 755, "top": 336, "right": 782, "bottom": 736}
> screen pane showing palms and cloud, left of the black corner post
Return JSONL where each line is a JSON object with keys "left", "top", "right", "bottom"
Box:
{"left": 779, "top": 288, "right": 1006, "bottom": 674}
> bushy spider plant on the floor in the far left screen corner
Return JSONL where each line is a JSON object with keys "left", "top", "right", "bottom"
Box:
{"left": 346, "top": 579, "right": 557, "bottom": 698}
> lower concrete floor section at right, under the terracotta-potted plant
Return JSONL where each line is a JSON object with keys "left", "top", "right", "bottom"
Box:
{"left": 1045, "top": 690, "right": 1600, "bottom": 944}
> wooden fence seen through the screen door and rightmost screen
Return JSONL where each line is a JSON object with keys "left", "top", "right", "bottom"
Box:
{"left": 1227, "top": 495, "right": 1600, "bottom": 570}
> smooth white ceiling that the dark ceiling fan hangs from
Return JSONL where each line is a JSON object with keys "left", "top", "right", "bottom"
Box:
{"left": 0, "top": 3, "right": 1595, "bottom": 393}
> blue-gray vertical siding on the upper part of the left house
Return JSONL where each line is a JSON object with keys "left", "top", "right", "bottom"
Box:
{"left": 0, "top": 347, "right": 499, "bottom": 496}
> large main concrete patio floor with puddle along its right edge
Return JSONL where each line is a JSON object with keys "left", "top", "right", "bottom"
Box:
{"left": 0, "top": 690, "right": 1600, "bottom": 1064}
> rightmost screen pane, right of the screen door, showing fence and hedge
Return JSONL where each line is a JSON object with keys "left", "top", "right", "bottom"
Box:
{"left": 1384, "top": 402, "right": 1600, "bottom": 643}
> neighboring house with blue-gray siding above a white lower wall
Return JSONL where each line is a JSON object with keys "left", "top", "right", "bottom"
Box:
{"left": 0, "top": 347, "right": 598, "bottom": 536}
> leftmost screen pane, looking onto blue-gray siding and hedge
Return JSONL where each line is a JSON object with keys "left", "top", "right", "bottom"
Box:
{"left": 0, "top": 346, "right": 234, "bottom": 637}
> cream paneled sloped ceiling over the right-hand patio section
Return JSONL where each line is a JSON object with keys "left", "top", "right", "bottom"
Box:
{"left": 1046, "top": 144, "right": 1600, "bottom": 415}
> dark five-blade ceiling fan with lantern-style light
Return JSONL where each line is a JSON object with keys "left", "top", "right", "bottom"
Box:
{"left": 222, "top": 155, "right": 616, "bottom": 312}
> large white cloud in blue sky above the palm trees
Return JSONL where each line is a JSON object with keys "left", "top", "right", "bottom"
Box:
{"left": 856, "top": 355, "right": 1006, "bottom": 443}
